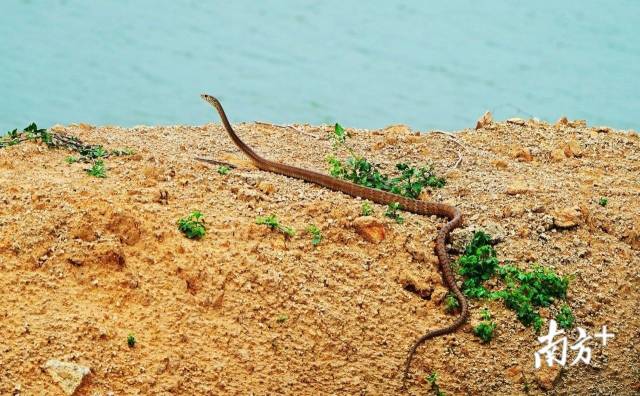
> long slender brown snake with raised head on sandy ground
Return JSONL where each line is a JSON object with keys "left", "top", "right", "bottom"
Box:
{"left": 196, "top": 94, "right": 469, "bottom": 389}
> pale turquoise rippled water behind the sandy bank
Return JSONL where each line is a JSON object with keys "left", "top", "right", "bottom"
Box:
{"left": 0, "top": 0, "right": 640, "bottom": 131}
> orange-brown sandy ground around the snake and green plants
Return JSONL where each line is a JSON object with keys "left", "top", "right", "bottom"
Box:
{"left": 0, "top": 116, "right": 640, "bottom": 395}
